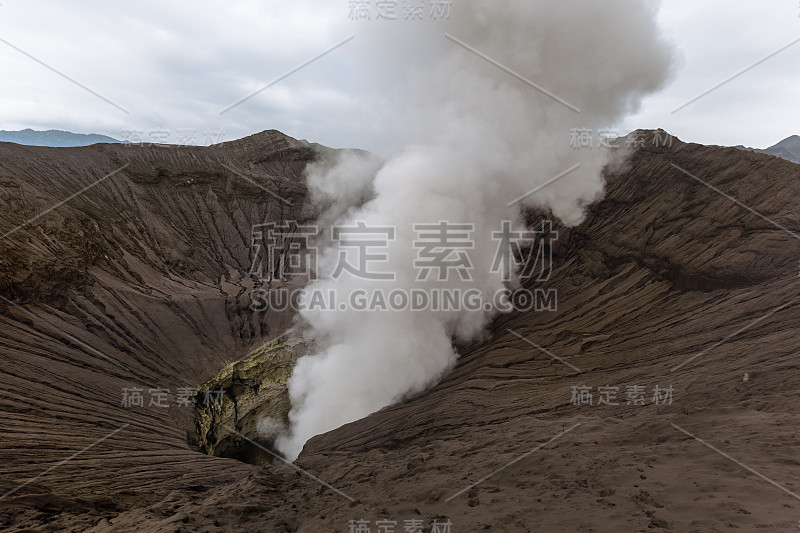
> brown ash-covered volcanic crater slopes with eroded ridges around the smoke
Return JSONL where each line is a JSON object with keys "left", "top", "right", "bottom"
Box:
{"left": 0, "top": 132, "right": 800, "bottom": 532}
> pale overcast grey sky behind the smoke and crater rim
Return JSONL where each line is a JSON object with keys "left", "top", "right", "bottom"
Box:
{"left": 0, "top": 0, "right": 800, "bottom": 155}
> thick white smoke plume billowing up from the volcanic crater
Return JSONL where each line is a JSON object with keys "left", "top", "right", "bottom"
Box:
{"left": 276, "top": 0, "right": 672, "bottom": 458}
